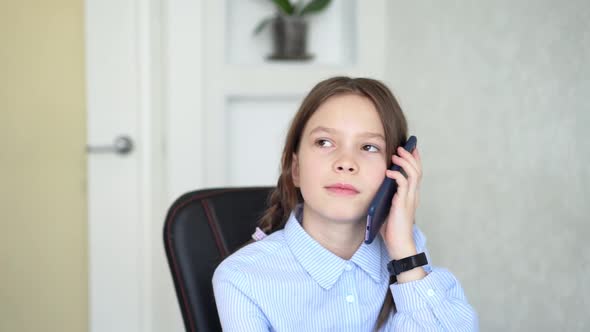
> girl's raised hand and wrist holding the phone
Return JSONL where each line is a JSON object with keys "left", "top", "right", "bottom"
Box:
{"left": 381, "top": 146, "right": 422, "bottom": 259}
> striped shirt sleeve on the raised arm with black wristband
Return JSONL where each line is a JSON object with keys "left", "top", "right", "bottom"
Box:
{"left": 386, "top": 227, "right": 479, "bottom": 332}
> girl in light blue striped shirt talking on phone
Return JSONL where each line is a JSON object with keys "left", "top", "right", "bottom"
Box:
{"left": 213, "top": 77, "right": 478, "bottom": 331}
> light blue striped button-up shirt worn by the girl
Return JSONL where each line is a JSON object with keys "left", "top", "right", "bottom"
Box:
{"left": 213, "top": 211, "right": 478, "bottom": 332}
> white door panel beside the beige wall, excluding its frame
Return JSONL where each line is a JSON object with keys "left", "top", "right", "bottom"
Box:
{"left": 85, "top": 0, "right": 142, "bottom": 332}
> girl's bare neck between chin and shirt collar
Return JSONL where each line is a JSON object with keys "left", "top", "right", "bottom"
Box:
{"left": 302, "top": 208, "right": 365, "bottom": 260}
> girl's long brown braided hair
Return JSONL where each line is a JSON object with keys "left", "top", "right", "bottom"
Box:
{"left": 260, "top": 77, "right": 407, "bottom": 329}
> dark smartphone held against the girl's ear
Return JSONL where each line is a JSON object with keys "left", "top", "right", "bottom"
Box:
{"left": 365, "top": 136, "right": 418, "bottom": 244}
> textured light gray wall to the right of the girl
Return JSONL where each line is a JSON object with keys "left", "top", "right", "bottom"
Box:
{"left": 387, "top": 0, "right": 590, "bottom": 331}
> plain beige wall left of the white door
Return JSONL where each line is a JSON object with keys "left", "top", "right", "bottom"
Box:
{"left": 0, "top": 0, "right": 88, "bottom": 332}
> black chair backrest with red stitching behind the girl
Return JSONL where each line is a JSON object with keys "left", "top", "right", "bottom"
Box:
{"left": 164, "top": 187, "right": 273, "bottom": 331}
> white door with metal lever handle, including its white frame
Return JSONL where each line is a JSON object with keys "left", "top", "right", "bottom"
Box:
{"left": 85, "top": 0, "right": 163, "bottom": 332}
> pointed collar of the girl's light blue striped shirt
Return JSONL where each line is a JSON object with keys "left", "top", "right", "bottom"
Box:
{"left": 285, "top": 204, "right": 383, "bottom": 289}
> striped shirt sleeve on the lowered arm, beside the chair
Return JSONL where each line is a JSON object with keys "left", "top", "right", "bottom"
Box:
{"left": 213, "top": 263, "right": 270, "bottom": 332}
